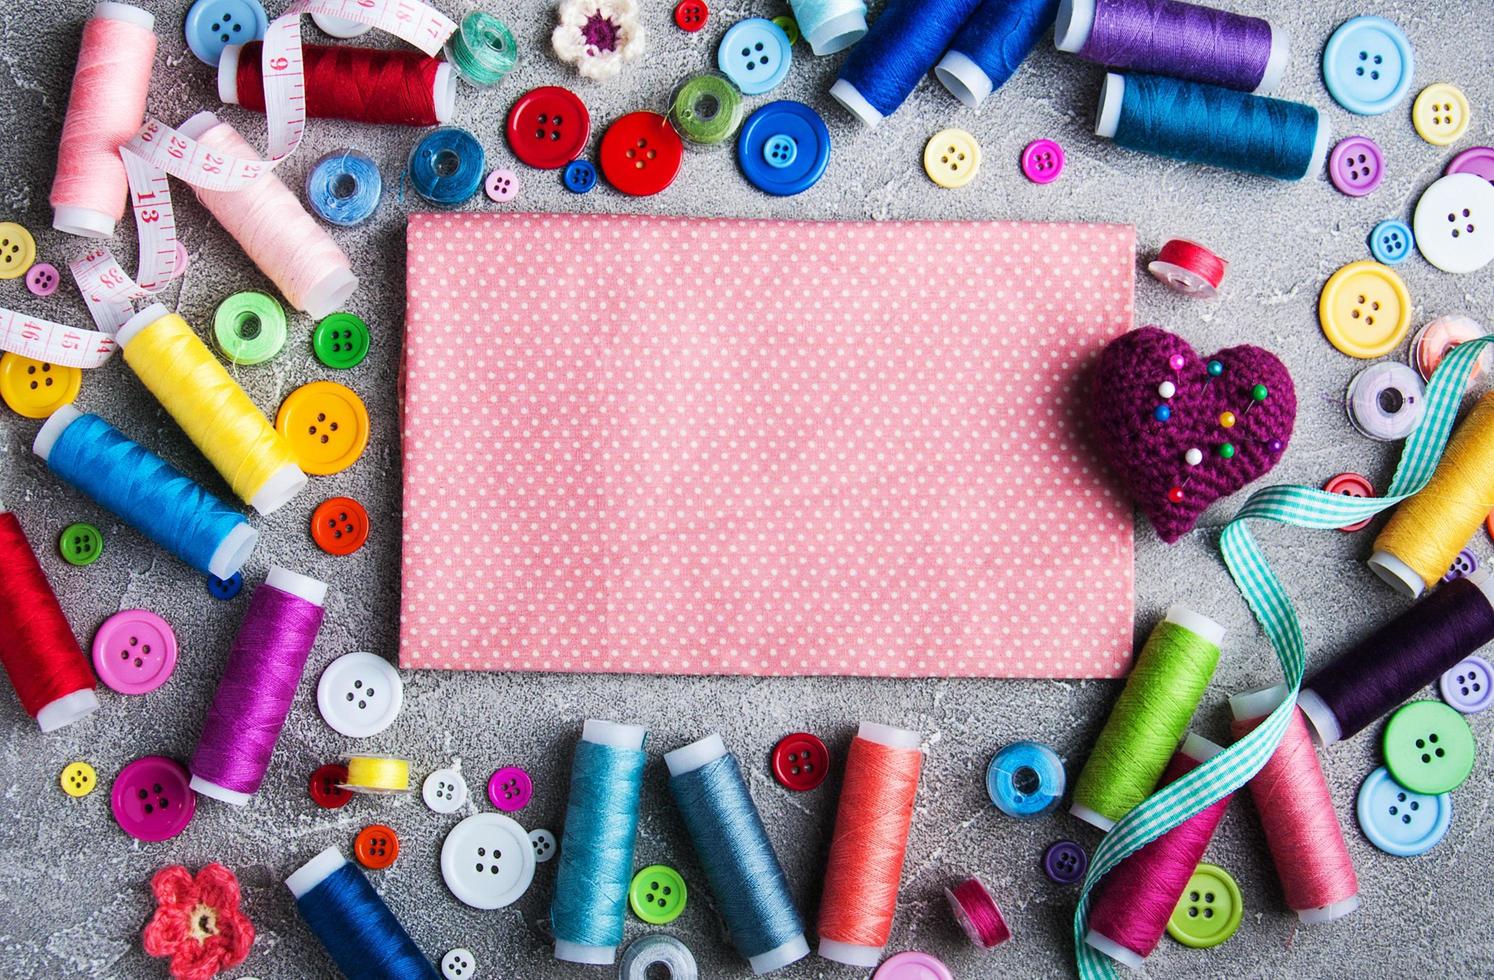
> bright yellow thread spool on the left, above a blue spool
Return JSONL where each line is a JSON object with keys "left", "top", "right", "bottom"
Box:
{"left": 115, "top": 303, "right": 306, "bottom": 514}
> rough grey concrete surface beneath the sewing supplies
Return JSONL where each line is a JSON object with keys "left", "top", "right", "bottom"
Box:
{"left": 0, "top": 0, "right": 1494, "bottom": 979}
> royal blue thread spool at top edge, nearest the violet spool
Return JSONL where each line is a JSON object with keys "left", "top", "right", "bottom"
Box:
{"left": 934, "top": 0, "right": 1058, "bottom": 108}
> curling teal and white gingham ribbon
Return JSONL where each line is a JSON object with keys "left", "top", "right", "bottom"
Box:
{"left": 1074, "top": 336, "right": 1494, "bottom": 980}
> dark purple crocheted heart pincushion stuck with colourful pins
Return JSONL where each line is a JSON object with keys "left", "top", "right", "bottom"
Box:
{"left": 1091, "top": 327, "right": 1297, "bottom": 544}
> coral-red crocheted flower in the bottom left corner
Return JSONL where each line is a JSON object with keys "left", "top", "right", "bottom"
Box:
{"left": 145, "top": 863, "right": 254, "bottom": 980}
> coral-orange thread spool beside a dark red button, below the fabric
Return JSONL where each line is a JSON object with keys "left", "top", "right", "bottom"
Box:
{"left": 819, "top": 722, "right": 923, "bottom": 968}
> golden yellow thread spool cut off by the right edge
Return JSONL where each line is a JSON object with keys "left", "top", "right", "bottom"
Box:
{"left": 1370, "top": 391, "right": 1494, "bottom": 598}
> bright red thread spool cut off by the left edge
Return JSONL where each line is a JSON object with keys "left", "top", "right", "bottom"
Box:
{"left": 0, "top": 503, "right": 99, "bottom": 732}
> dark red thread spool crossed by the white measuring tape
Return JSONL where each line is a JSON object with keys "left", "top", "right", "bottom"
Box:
{"left": 218, "top": 40, "right": 457, "bottom": 125}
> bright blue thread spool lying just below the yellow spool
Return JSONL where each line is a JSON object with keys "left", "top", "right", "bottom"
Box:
{"left": 31, "top": 405, "right": 260, "bottom": 578}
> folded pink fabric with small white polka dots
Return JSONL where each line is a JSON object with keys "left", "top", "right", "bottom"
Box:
{"left": 400, "top": 214, "right": 1134, "bottom": 677}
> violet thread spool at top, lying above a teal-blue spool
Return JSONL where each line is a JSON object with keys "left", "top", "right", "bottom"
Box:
{"left": 1053, "top": 0, "right": 1291, "bottom": 96}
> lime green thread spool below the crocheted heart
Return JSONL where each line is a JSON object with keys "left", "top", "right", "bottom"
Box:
{"left": 1068, "top": 605, "right": 1224, "bottom": 831}
